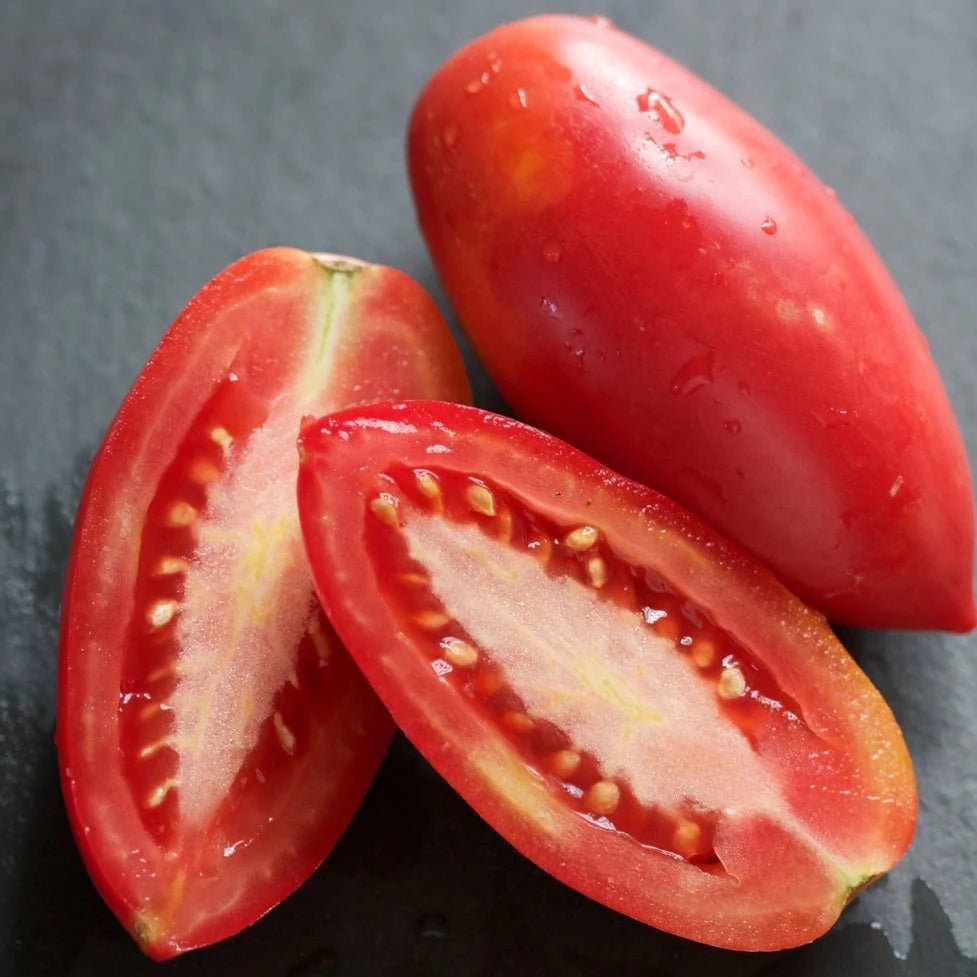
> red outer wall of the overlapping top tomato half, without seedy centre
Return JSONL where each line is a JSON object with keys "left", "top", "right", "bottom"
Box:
{"left": 298, "top": 402, "right": 916, "bottom": 950}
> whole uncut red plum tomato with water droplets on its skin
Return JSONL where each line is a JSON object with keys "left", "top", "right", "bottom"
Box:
{"left": 409, "top": 16, "right": 975, "bottom": 630}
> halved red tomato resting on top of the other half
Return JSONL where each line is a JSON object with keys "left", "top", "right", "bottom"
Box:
{"left": 298, "top": 402, "right": 916, "bottom": 950}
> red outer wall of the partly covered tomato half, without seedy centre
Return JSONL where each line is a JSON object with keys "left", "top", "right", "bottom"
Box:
{"left": 57, "top": 248, "right": 470, "bottom": 960}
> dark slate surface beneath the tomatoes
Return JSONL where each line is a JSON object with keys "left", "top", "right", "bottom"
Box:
{"left": 0, "top": 0, "right": 977, "bottom": 977}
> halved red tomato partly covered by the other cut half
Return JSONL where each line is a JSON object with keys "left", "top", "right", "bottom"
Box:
{"left": 57, "top": 248, "right": 468, "bottom": 959}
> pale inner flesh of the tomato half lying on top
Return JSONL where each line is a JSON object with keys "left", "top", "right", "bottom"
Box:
{"left": 403, "top": 511, "right": 779, "bottom": 814}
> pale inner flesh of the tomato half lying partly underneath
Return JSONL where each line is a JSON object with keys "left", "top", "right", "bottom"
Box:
{"left": 170, "top": 407, "right": 314, "bottom": 824}
